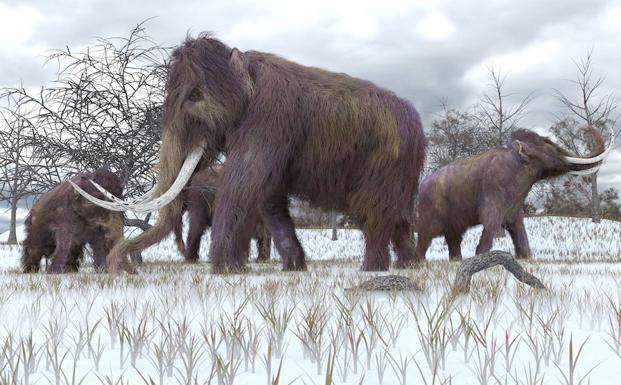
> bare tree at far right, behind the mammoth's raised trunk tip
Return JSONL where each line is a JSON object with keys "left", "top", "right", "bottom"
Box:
{"left": 556, "top": 51, "right": 618, "bottom": 223}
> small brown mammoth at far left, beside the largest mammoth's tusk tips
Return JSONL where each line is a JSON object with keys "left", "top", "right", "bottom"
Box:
{"left": 21, "top": 168, "right": 123, "bottom": 273}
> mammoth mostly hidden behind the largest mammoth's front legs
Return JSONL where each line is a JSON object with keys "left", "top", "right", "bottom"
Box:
{"left": 174, "top": 167, "right": 272, "bottom": 262}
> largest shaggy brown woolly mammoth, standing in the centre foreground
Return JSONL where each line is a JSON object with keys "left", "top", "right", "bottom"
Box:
{"left": 70, "top": 35, "right": 426, "bottom": 272}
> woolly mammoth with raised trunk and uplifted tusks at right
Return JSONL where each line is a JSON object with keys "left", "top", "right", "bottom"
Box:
{"left": 416, "top": 127, "right": 614, "bottom": 261}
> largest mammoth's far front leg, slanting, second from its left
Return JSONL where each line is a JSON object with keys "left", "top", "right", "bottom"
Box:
{"left": 259, "top": 194, "right": 306, "bottom": 271}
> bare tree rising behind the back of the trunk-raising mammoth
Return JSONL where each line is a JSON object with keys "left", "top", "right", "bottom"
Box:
{"left": 476, "top": 68, "right": 534, "bottom": 148}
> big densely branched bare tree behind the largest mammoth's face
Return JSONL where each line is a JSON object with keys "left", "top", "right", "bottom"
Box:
{"left": 8, "top": 23, "right": 169, "bottom": 244}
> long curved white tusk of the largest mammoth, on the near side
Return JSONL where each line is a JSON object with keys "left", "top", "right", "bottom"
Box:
{"left": 69, "top": 147, "right": 203, "bottom": 213}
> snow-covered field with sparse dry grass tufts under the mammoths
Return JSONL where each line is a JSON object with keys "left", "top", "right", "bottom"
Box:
{"left": 0, "top": 218, "right": 621, "bottom": 385}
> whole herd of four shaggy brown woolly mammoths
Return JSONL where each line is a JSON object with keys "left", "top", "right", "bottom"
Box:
{"left": 22, "top": 34, "right": 614, "bottom": 273}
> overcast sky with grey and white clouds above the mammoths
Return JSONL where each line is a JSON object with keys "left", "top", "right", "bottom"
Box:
{"left": 0, "top": 0, "right": 621, "bottom": 228}
